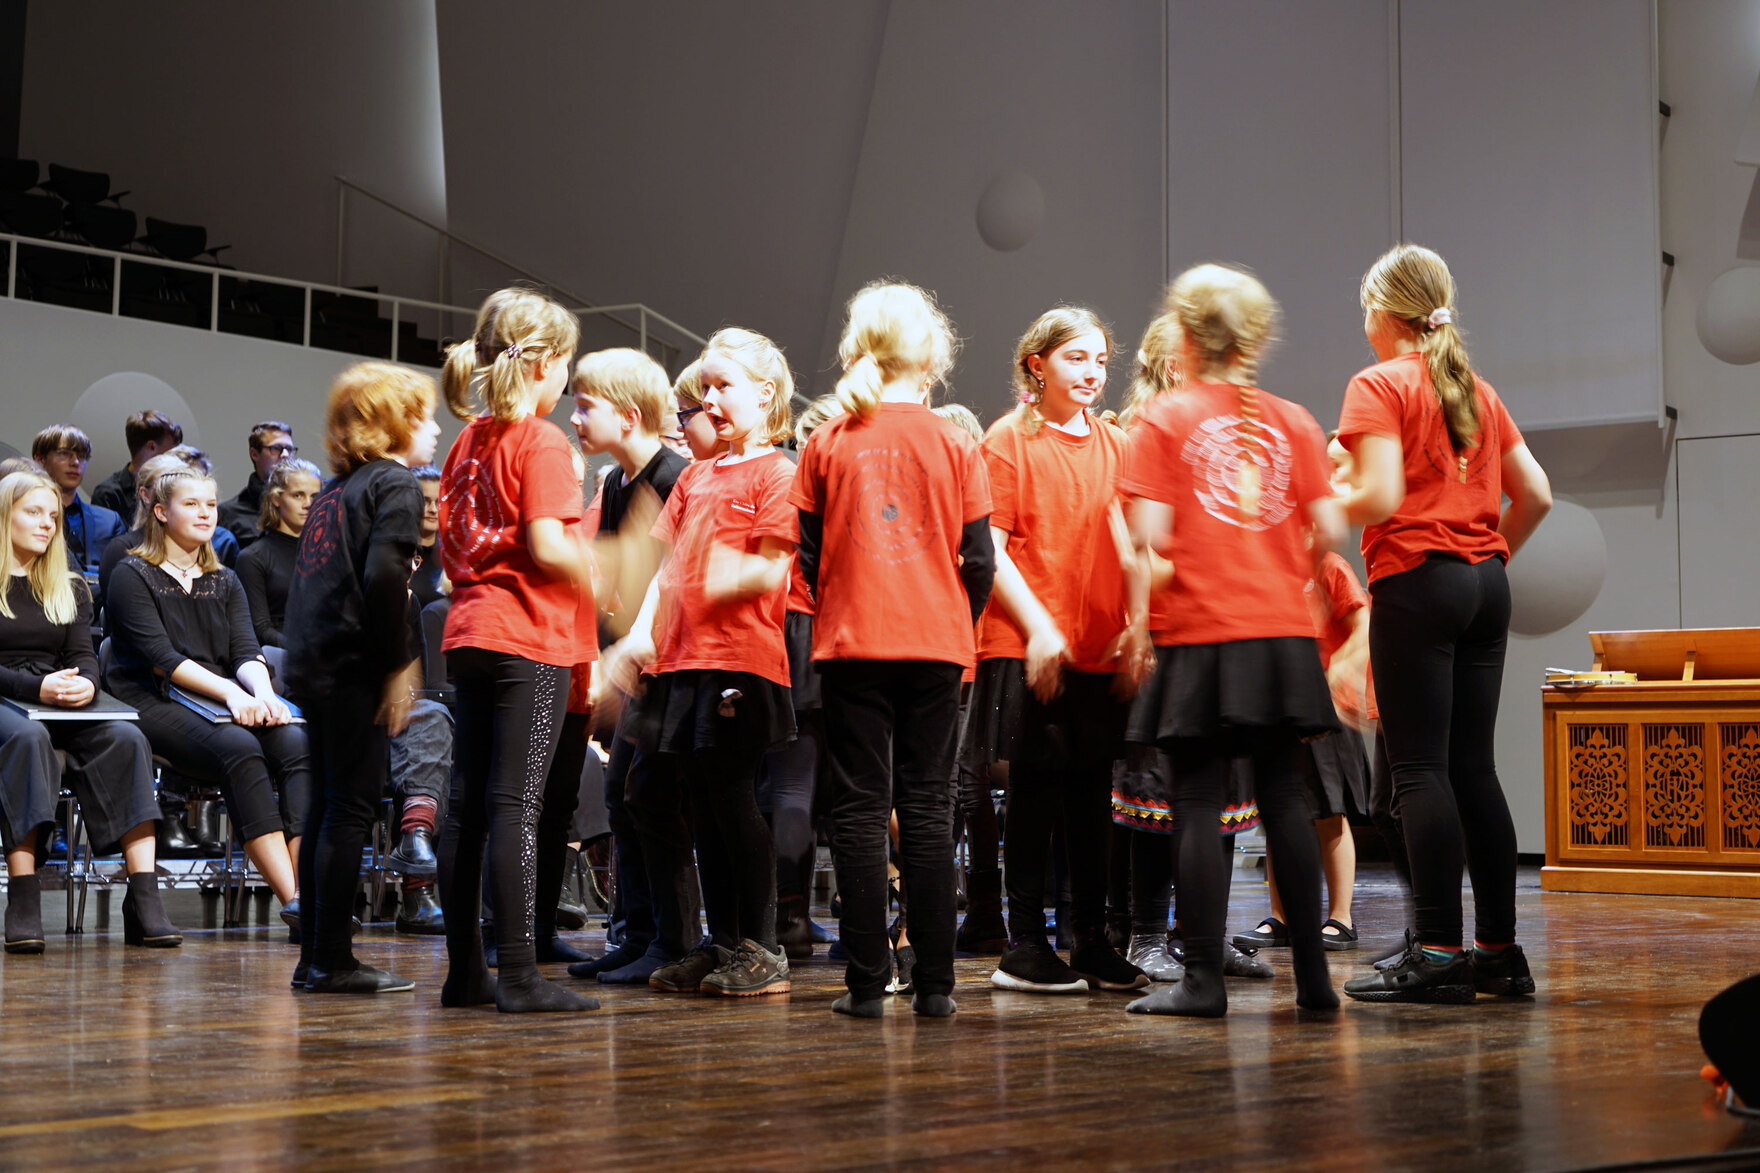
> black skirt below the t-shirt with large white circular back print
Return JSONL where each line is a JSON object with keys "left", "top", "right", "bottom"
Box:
{"left": 1125, "top": 636, "right": 1339, "bottom": 745}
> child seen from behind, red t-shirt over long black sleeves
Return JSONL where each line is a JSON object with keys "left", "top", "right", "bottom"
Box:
{"left": 792, "top": 282, "right": 994, "bottom": 1018}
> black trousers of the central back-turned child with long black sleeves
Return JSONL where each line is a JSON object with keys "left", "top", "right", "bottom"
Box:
{"left": 818, "top": 660, "right": 964, "bottom": 999}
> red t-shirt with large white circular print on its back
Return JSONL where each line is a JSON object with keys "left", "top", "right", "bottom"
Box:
{"left": 1123, "top": 384, "right": 1331, "bottom": 646}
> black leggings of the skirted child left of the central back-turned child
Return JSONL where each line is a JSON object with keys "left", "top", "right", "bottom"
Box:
{"left": 678, "top": 747, "right": 776, "bottom": 953}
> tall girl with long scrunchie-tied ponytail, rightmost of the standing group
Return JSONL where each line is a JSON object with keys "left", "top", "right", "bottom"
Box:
{"left": 1338, "top": 245, "right": 1552, "bottom": 1002}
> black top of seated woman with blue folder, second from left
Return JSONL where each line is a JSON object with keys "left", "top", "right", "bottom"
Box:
{"left": 104, "top": 555, "right": 262, "bottom": 703}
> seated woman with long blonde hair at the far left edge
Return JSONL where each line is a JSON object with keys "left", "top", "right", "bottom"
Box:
{"left": 0, "top": 472, "right": 183, "bottom": 953}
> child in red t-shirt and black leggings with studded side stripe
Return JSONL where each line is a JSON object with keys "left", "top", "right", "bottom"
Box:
{"left": 440, "top": 289, "right": 598, "bottom": 1011}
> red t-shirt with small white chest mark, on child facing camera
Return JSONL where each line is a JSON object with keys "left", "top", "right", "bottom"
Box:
{"left": 648, "top": 451, "right": 799, "bottom": 685}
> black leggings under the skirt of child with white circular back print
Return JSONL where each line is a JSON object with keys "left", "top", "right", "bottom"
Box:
{"left": 1165, "top": 727, "right": 1320, "bottom": 951}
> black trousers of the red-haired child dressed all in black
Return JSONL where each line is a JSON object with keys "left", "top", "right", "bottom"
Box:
{"left": 299, "top": 687, "right": 391, "bottom": 972}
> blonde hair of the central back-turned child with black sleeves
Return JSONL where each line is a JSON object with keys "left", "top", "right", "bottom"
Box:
{"left": 836, "top": 280, "right": 959, "bottom": 419}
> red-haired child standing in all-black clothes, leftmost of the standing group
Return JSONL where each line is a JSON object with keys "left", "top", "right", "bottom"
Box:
{"left": 287, "top": 363, "right": 440, "bottom": 993}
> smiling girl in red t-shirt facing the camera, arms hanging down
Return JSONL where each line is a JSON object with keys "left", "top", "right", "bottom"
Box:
{"left": 961, "top": 306, "right": 1149, "bottom": 993}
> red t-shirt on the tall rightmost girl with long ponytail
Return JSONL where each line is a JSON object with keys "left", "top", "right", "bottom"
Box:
{"left": 1338, "top": 350, "right": 1522, "bottom": 583}
